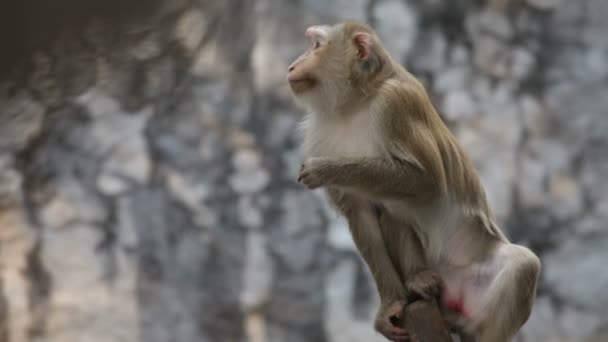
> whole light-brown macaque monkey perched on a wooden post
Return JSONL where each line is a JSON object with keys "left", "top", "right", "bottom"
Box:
{"left": 287, "top": 22, "right": 541, "bottom": 342}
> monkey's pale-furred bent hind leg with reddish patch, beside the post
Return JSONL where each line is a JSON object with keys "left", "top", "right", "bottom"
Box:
{"left": 442, "top": 244, "right": 540, "bottom": 342}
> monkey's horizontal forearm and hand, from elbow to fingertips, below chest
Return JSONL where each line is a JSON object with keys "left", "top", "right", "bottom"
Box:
{"left": 298, "top": 157, "right": 437, "bottom": 204}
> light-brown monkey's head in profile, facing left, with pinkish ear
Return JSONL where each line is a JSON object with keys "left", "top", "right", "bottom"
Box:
{"left": 287, "top": 22, "right": 390, "bottom": 110}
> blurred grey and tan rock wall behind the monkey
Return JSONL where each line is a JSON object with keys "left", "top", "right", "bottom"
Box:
{"left": 0, "top": 0, "right": 608, "bottom": 342}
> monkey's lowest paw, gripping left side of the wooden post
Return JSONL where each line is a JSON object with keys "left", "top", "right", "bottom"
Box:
{"left": 374, "top": 300, "right": 410, "bottom": 342}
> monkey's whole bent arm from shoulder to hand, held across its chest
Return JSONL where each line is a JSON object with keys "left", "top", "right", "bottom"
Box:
{"left": 299, "top": 79, "right": 449, "bottom": 203}
